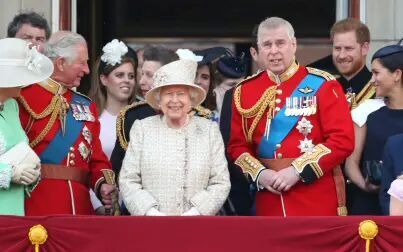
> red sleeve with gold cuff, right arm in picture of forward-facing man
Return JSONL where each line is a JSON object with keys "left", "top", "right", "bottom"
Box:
{"left": 292, "top": 80, "right": 354, "bottom": 183}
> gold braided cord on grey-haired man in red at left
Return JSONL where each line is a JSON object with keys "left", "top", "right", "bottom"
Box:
{"left": 18, "top": 95, "right": 68, "bottom": 148}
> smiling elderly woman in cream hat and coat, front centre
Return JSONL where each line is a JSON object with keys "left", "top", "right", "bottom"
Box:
{"left": 119, "top": 49, "right": 230, "bottom": 216}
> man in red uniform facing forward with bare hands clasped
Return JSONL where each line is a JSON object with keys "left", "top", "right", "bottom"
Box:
{"left": 228, "top": 17, "right": 354, "bottom": 216}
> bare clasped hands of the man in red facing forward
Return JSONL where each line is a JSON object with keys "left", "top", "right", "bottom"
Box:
{"left": 258, "top": 166, "right": 300, "bottom": 194}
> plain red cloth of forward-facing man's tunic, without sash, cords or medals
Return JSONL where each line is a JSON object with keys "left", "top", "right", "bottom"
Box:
{"left": 228, "top": 66, "right": 354, "bottom": 216}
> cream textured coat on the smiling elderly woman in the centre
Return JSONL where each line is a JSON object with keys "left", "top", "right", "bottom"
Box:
{"left": 119, "top": 115, "right": 230, "bottom": 215}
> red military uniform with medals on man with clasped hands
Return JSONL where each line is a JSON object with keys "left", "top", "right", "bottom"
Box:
{"left": 228, "top": 63, "right": 354, "bottom": 216}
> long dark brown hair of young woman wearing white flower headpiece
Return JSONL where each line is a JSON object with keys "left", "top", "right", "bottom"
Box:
{"left": 88, "top": 45, "right": 138, "bottom": 113}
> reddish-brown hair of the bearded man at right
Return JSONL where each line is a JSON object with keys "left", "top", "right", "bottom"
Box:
{"left": 330, "top": 18, "right": 371, "bottom": 45}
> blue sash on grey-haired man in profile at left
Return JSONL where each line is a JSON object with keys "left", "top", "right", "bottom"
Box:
{"left": 40, "top": 94, "right": 90, "bottom": 164}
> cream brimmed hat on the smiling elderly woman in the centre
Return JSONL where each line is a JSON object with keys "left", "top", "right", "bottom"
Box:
{"left": 145, "top": 49, "right": 206, "bottom": 109}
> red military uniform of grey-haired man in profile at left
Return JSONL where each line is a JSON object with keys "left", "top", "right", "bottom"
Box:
{"left": 19, "top": 79, "right": 111, "bottom": 216}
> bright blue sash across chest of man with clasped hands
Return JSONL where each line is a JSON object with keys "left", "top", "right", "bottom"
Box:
{"left": 258, "top": 74, "right": 325, "bottom": 158}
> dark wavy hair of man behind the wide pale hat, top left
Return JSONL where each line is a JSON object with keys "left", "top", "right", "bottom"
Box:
{"left": 7, "top": 12, "right": 50, "bottom": 40}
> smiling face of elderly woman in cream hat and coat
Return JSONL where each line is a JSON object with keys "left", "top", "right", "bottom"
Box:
{"left": 160, "top": 85, "right": 192, "bottom": 121}
